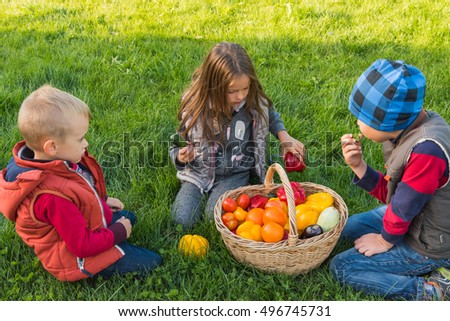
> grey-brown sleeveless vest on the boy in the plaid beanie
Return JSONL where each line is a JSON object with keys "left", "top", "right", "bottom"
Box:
{"left": 383, "top": 111, "right": 450, "bottom": 259}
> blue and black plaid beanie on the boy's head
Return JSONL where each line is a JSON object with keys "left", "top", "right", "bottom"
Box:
{"left": 348, "top": 59, "right": 426, "bottom": 132}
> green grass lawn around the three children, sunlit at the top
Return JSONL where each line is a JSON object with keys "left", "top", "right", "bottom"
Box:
{"left": 0, "top": 0, "right": 450, "bottom": 301}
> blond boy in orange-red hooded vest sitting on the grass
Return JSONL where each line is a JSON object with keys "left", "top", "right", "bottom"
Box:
{"left": 0, "top": 85, "right": 162, "bottom": 281}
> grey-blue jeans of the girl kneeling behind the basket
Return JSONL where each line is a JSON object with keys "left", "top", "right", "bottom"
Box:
{"left": 172, "top": 172, "right": 250, "bottom": 228}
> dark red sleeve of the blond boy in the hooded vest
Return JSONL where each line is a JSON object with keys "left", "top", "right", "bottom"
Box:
{"left": 34, "top": 194, "right": 126, "bottom": 258}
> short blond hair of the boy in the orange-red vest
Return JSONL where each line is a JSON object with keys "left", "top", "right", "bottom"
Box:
{"left": 18, "top": 85, "right": 91, "bottom": 151}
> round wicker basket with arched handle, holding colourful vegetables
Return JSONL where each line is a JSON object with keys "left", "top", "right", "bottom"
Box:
{"left": 214, "top": 163, "right": 348, "bottom": 275}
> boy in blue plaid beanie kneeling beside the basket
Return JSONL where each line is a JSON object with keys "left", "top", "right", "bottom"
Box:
{"left": 330, "top": 59, "right": 450, "bottom": 300}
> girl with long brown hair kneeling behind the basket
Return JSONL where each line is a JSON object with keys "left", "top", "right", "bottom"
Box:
{"left": 170, "top": 42, "right": 305, "bottom": 228}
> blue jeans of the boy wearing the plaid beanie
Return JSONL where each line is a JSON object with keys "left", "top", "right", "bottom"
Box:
{"left": 330, "top": 206, "right": 450, "bottom": 300}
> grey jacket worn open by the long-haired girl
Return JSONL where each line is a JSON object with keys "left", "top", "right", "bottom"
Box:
{"left": 169, "top": 105, "right": 286, "bottom": 193}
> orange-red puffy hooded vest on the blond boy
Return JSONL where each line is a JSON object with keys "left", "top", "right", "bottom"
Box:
{"left": 0, "top": 142, "right": 123, "bottom": 281}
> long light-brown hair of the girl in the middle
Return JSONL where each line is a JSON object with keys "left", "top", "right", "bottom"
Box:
{"left": 178, "top": 42, "right": 272, "bottom": 141}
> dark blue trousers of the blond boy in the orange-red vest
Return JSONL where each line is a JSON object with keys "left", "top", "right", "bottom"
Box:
{"left": 96, "top": 210, "right": 162, "bottom": 278}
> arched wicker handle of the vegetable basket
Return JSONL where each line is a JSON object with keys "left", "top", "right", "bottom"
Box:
{"left": 264, "top": 163, "right": 298, "bottom": 246}
